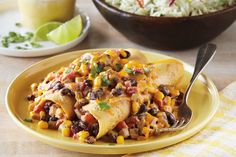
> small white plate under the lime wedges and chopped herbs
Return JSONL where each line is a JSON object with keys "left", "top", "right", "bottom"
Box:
{"left": 0, "top": 1, "right": 91, "bottom": 57}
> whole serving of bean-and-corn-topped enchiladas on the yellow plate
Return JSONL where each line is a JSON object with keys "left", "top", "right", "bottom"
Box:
{"left": 25, "top": 49, "right": 184, "bottom": 144}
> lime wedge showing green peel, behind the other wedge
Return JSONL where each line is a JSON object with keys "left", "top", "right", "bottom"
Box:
{"left": 33, "top": 22, "right": 62, "bottom": 41}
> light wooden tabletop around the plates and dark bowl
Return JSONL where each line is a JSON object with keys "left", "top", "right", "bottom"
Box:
{"left": 0, "top": 0, "right": 236, "bottom": 157}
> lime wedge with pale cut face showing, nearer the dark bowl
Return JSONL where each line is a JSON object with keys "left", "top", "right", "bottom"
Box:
{"left": 47, "top": 15, "right": 83, "bottom": 44}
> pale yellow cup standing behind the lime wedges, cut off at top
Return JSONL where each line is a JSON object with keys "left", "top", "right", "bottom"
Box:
{"left": 18, "top": 0, "right": 76, "bottom": 29}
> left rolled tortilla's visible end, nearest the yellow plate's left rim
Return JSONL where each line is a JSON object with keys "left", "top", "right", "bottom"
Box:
{"left": 44, "top": 91, "right": 76, "bottom": 119}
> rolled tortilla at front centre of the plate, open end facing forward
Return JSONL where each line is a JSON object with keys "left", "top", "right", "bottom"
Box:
{"left": 83, "top": 97, "right": 130, "bottom": 139}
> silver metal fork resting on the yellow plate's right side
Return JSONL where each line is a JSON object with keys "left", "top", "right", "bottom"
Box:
{"left": 155, "top": 43, "right": 216, "bottom": 133}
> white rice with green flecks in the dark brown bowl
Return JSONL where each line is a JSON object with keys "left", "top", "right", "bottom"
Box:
{"left": 105, "top": 0, "right": 236, "bottom": 17}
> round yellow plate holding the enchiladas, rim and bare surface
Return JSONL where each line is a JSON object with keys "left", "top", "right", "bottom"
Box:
{"left": 6, "top": 49, "right": 219, "bottom": 154}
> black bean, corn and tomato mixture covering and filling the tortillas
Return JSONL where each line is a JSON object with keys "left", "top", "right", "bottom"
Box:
{"left": 26, "top": 49, "right": 183, "bottom": 144}
